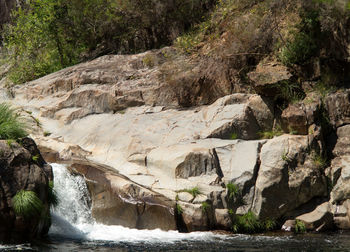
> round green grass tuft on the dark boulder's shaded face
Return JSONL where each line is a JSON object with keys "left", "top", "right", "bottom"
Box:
{"left": 12, "top": 190, "right": 44, "bottom": 218}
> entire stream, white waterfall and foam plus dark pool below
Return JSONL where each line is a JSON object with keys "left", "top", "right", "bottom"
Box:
{"left": 0, "top": 164, "right": 350, "bottom": 252}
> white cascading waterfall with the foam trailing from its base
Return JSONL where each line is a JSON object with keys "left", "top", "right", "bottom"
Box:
{"left": 49, "top": 164, "right": 219, "bottom": 242}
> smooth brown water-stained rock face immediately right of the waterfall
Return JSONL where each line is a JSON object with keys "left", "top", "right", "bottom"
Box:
{"left": 70, "top": 160, "right": 176, "bottom": 230}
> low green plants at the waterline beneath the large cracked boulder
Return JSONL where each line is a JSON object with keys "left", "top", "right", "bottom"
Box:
{"left": 232, "top": 211, "right": 277, "bottom": 234}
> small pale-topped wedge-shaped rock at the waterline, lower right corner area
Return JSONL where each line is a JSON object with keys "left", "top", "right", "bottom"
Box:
{"left": 296, "top": 202, "right": 334, "bottom": 231}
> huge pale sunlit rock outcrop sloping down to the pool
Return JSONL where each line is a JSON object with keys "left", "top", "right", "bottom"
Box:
{"left": 3, "top": 48, "right": 350, "bottom": 234}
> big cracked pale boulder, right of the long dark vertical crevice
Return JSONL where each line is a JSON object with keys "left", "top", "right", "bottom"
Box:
{"left": 252, "top": 135, "right": 327, "bottom": 218}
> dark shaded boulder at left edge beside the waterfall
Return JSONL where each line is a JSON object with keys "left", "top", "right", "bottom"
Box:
{"left": 0, "top": 138, "right": 53, "bottom": 242}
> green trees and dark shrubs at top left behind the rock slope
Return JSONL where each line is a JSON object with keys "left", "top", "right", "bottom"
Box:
{"left": 3, "top": 0, "right": 213, "bottom": 83}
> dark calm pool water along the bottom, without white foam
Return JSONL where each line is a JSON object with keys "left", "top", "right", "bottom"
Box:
{"left": 0, "top": 232, "right": 350, "bottom": 252}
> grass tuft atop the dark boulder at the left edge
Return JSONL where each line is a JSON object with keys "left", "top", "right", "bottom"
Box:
{"left": 0, "top": 103, "right": 27, "bottom": 139}
